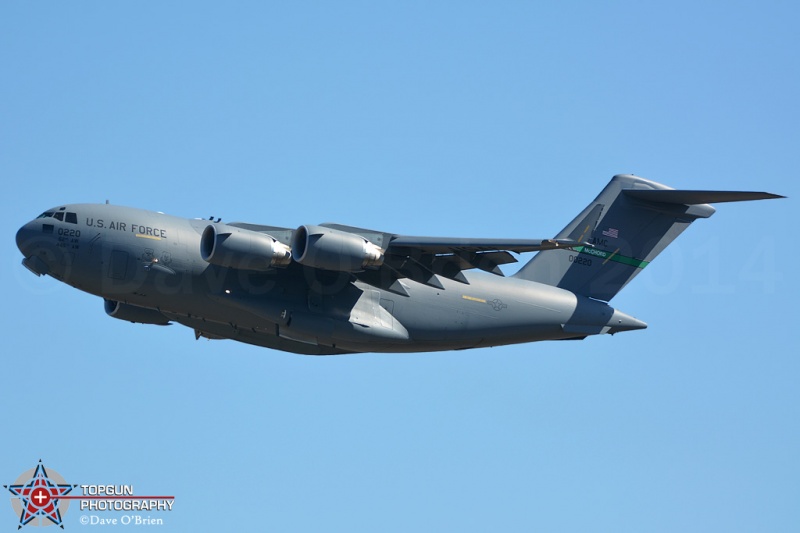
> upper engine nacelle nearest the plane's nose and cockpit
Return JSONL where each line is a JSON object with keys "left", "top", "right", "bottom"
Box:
{"left": 200, "top": 224, "right": 292, "bottom": 271}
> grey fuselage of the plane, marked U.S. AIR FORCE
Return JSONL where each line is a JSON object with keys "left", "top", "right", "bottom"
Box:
{"left": 17, "top": 204, "right": 646, "bottom": 354}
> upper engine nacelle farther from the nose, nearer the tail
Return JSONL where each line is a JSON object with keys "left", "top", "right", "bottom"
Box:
{"left": 292, "top": 226, "right": 383, "bottom": 272}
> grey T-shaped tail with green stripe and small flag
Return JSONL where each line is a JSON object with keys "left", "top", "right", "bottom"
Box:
{"left": 515, "top": 174, "right": 783, "bottom": 301}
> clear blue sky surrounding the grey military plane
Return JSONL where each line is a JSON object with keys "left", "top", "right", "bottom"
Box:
{"left": 0, "top": 1, "right": 800, "bottom": 532}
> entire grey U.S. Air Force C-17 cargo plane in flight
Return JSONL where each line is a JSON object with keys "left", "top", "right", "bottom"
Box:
{"left": 17, "top": 175, "right": 782, "bottom": 355}
